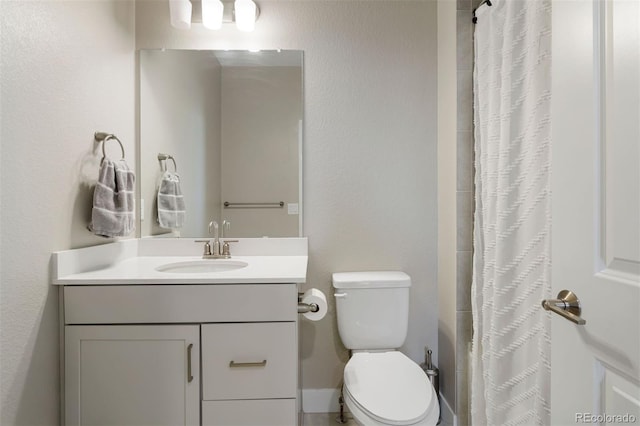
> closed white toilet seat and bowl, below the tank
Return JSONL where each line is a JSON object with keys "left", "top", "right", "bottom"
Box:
{"left": 344, "top": 351, "right": 439, "bottom": 425}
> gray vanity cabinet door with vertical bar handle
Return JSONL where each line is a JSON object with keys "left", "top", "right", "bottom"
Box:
{"left": 65, "top": 325, "right": 200, "bottom": 426}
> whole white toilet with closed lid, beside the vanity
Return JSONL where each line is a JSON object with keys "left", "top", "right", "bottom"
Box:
{"left": 333, "top": 271, "right": 440, "bottom": 426}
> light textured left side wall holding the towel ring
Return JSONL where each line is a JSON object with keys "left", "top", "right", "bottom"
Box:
{"left": 0, "top": 1, "right": 136, "bottom": 425}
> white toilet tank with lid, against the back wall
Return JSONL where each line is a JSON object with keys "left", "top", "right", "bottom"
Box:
{"left": 333, "top": 271, "right": 411, "bottom": 350}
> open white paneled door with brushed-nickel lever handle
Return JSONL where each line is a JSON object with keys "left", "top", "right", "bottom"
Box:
{"left": 550, "top": 0, "right": 640, "bottom": 425}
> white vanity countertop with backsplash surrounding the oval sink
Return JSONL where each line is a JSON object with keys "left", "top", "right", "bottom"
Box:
{"left": 52, "top": 238, "right": 307, "bottom": 285}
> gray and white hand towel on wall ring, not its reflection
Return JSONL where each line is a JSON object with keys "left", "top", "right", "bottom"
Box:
{"left": 89, "top": 158, "right": 136, "bottom": 237}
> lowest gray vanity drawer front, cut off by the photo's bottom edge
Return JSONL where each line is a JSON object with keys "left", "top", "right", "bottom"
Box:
{"left": 202, "top": 399, "right": 297, "bottom": 426}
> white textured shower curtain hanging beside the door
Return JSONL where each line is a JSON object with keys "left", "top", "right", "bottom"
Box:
{"left": 470, "top": 0, "right": 551, "bottom": 426}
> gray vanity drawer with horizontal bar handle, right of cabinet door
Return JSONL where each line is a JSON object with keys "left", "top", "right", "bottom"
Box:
{"left": 202, "top": 322, "right": 298, "bottom": 400}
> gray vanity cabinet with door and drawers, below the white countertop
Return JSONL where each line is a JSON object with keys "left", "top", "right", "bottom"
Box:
{"left": 62, "top": 283, "right": 298, "bottom": 426}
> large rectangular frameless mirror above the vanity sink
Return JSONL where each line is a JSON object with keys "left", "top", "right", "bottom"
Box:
{"left": 138, "top": 50, "right": 303, "bottom": 237}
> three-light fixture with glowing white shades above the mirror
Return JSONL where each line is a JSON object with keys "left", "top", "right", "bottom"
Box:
{"left": 169, "top": 0, "right": 260, "bottom": 32}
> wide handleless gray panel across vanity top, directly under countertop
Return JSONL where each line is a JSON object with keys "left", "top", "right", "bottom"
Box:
{"left": 64, "top": 284, "right": 298, "bottom": 324}
